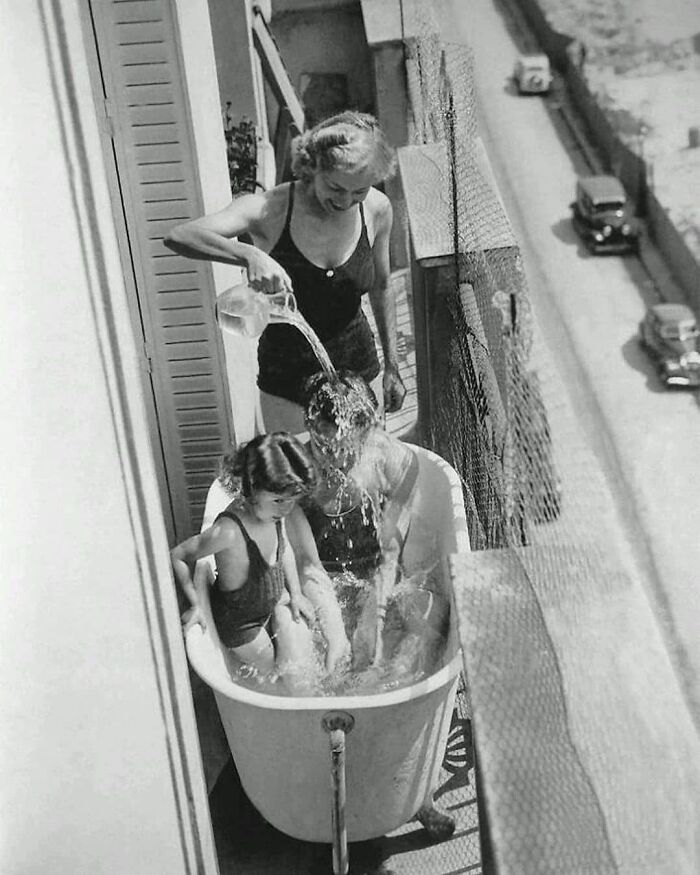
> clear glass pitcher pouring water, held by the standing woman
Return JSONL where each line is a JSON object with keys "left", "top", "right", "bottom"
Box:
{"left": 216, "top": 282, "right": 297, "bottom": 338}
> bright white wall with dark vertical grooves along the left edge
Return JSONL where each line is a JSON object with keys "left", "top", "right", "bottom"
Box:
{"left": 0, "top": 0, "right": 217, "bottom": 875}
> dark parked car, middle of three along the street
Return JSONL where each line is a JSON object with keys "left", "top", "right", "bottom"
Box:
{"left": 571, "top": 175, "right": 642, "bottom": 252}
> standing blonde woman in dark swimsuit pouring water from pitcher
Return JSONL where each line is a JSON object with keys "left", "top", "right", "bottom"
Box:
{"left": 165, "top": 111, "right": 406, "bottom": 433}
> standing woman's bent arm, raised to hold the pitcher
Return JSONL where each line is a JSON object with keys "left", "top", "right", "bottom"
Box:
{"left": 163, "top": 192, "right": 292, "bottom": 294}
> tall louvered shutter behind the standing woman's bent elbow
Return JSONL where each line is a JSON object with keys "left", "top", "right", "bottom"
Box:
{"left": 91, "top": 0, "right": 232, "bottom": 539}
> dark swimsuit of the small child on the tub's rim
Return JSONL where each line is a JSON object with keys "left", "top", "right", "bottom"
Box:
{"left": 211, "top": 511, "right": 285, "bottom": 647}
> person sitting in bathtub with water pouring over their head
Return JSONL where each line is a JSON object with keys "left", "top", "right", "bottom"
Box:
{"left": 302, "top": 371, "right": 447, "bottom": 670}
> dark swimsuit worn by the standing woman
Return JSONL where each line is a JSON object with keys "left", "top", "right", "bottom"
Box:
{"left": 258, "top": 183, "right": 380, "bottom": 406}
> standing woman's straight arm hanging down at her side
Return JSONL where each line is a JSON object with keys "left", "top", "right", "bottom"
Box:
{"left": 369, "top": 192, "right": 406, "bottom": 413}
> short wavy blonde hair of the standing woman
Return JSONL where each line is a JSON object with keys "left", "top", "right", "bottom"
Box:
{"left": 292, "top": 110, "right": 396, "bottom": 182}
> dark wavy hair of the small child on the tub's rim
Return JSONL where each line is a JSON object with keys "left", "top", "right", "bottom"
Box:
{"left": 219, "top": 431, "right": 318, "bottom": 498}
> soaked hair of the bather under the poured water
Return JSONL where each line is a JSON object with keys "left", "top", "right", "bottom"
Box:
{"left": 304, "top": 370, "right": 379, "bottom": 433}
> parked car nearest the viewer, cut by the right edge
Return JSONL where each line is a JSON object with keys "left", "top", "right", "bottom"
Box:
{"left": 639, "top": 304, "right": 700, "bottom": 388}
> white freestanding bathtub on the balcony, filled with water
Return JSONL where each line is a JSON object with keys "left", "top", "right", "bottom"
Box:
{"left": 186, "top": 447, "right": 469, "bottom": 843}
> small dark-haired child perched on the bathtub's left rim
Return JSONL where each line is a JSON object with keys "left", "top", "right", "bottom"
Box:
{"left": 171, "top": 432, "right": 349, "bottom": 687}
